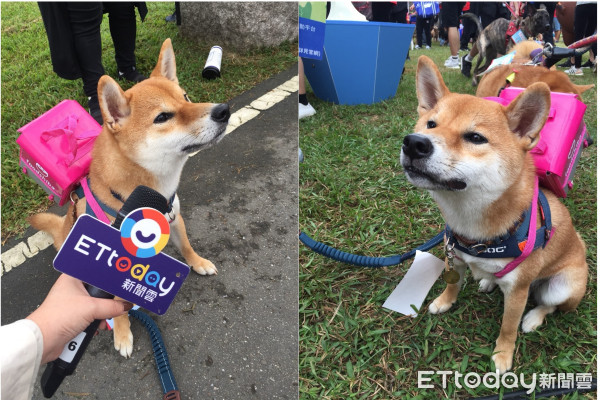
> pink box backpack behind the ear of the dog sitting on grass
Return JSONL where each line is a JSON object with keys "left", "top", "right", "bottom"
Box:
{"left": 486, "top": 87, "right": 588, "bottom": 198}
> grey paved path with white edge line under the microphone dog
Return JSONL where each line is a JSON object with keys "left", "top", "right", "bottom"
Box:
{"left": 1, "top": 66, "right": 298, "bottom": 400}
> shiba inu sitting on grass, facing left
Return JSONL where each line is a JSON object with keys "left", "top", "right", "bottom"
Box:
{"left": 401, "top": 56, "right": 587, "bottom": 373}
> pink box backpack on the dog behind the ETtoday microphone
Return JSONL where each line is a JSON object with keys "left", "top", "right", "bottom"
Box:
{"left": 17, "top": 100, "right": 102, "bottom": 206}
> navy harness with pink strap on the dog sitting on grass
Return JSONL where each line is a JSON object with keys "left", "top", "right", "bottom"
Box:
{"left": 446, "top": 179, "right": 553, "bottom": 278}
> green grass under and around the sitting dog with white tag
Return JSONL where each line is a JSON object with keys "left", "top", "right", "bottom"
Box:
{"left": 299, "top": 44, "right": 597, "bottom": 399}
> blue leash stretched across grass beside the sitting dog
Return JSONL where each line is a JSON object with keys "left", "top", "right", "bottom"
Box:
{"left": 299, "top": 231, "right": 444, "bottom": 268}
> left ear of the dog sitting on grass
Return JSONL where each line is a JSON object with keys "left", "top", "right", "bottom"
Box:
{"left": 417, "top": 56, "right": 450, "bottom": 115}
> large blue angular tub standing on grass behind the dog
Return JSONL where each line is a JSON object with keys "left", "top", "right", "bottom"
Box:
{"left": 302, "top": 21, "right": 414, "bottom": 105}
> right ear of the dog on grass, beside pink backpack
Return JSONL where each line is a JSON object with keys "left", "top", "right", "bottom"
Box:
{"left": 505, "top": 82, "right": 550, "bottom": 150}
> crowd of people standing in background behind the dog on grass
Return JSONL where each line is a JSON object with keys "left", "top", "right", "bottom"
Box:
{"left": 299, "top": 1, "right": 597, "bottom": 118}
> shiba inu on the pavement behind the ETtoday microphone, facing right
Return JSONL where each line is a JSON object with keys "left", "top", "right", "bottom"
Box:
{"left": 30, "top": 39, "right": 230, "bottom": 357}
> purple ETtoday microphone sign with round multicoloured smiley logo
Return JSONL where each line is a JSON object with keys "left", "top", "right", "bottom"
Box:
{"left": 54, "top": 214, "right": 189, "bottom": 314}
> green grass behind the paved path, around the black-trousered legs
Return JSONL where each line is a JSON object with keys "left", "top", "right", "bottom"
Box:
{"left": 1, "top": 2, "right": 298, "bottom": 242}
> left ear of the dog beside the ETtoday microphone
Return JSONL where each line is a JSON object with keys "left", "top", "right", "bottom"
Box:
{"left": 98, "top": 75, "right": 131, "bottom": 133}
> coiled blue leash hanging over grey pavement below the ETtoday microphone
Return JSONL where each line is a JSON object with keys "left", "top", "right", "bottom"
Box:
{"left": 129, "top": 310, "right": 180, "bottom": 400}
